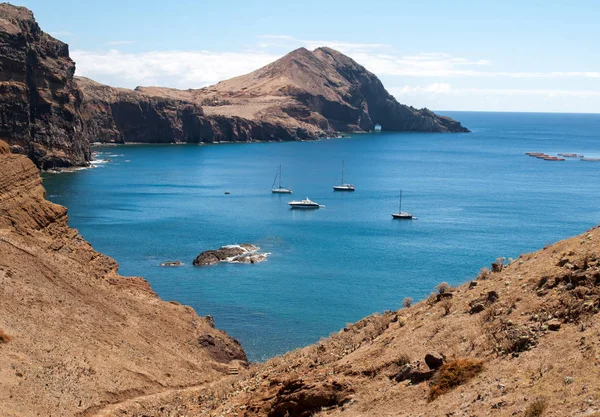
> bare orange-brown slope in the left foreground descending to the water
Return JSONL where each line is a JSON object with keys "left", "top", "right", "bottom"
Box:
{"left": 0, "top": 141, "right": 246, "bottom": 417}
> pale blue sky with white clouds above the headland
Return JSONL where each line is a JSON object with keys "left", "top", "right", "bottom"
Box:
{"left": 13, "top": 0, "right": 600, "bottom": 113}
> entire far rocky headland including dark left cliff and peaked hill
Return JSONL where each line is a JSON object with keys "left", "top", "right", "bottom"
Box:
{"left": 0, "top": 3, "right": 468, "bottom": 169}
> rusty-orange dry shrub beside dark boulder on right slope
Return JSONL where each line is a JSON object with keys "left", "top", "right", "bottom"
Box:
{"left": 429, "top": 358, "right": 483, "bottom": 401}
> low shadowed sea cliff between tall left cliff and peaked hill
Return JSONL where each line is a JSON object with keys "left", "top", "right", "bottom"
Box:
{"left": 76, "top": 77, "right": 309, "bottom": 143}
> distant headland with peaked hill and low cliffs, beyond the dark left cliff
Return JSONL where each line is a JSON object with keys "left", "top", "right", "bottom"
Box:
{"left": 77, "top": 48, "right": 468, "bottom": 143}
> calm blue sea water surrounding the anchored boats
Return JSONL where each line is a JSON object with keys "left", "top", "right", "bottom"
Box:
{"left": 44, "top": 112, "right": 600, "bottom": 360}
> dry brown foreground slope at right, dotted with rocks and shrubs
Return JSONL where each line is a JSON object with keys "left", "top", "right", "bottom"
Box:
{"left": 96, "top": 228, "right": 600, "bottom": 417}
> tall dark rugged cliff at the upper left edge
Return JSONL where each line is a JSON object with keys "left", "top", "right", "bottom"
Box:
{"left": 0, "top": 3, "right": 90, "bottom": 168}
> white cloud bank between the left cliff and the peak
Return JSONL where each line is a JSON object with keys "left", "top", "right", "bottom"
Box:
{"left": 71, "top": 49, "right": 278, "bottom": 88}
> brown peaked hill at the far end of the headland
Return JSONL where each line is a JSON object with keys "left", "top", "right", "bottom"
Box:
{"left": 136, "top": 48, "right": 468, "bottom": 137}
